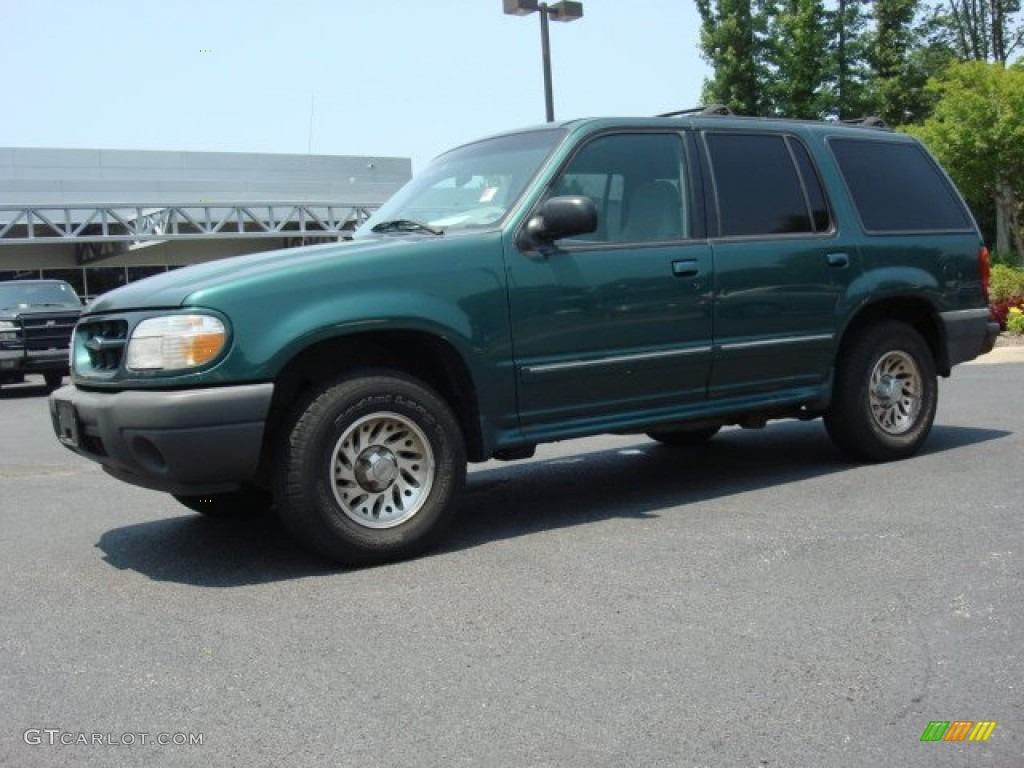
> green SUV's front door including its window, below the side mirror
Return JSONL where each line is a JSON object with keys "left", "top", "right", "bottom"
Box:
{"left": 508, "top": 132, "right": 712, "bottom": 439}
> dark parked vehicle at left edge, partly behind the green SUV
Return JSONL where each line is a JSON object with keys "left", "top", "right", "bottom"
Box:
{"left": 0, "top": 280, "right": 82, "bottom": 389}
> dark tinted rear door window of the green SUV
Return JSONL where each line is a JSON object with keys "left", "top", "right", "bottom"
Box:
{"left": 705, "top": 133, "right": 830, "bottom": 237}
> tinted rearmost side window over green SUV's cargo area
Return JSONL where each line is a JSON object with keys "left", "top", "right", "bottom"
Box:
{"left": 829, "top": 138, "right": 973, "bottom": 232}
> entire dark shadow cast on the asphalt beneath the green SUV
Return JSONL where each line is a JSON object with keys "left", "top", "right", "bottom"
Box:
{"left": 96, "top": 423, "right": 1011, "bottom": 587}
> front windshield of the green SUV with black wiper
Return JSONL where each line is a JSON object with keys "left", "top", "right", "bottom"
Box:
{"left": 355, "top": 129, "right": 565, "bottom": 238}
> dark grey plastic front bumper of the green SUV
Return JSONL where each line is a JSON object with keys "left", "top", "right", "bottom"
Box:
{"left": 49, "top": 383, "right": 273, "bottom": 496}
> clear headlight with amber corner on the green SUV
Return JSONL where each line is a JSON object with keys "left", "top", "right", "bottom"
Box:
{"left": 127, "top": 314, "right": 227, "bottom": 371}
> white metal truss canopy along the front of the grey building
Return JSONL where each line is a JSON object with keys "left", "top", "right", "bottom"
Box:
{"left": 0, "top": 201, "right": 377, "bottom": 263}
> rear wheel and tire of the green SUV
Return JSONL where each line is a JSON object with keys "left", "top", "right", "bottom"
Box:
{"left": 824, "top": 322, "right": 938, "bottom": 462}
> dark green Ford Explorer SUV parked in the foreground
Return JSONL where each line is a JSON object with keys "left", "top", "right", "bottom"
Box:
{"left": 50, "top": 114, "right": 997, "bottom": 563}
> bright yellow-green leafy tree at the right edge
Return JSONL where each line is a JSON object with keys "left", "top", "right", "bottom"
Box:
{"left": 909, "top": 61, "right": 1024, "bottom": 255}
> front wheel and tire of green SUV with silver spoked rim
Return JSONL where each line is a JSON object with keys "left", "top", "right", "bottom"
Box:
{"left": 274, "top": 372, "right": 466, "bottom": 565}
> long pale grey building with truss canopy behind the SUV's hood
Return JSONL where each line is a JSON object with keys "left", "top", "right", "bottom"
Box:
{"left": 0, "top": 147, "right": 412, "bottom": 297}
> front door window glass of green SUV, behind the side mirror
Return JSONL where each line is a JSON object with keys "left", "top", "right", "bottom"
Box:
{"left": 551, "top": 133, "right": 690, "bottom": 243}
